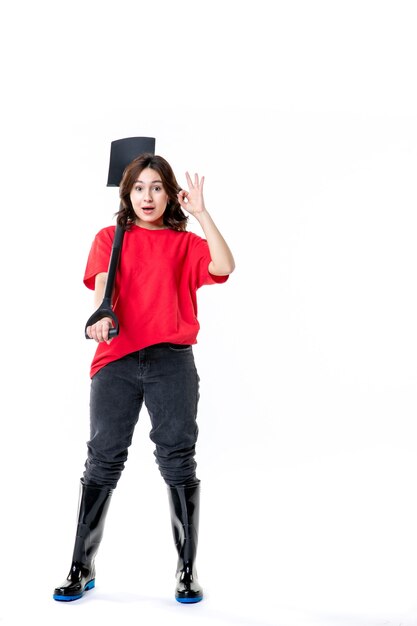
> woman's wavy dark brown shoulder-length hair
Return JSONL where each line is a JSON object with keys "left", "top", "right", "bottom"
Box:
{"left": 116, "top": 154, "right": 188, "bottom": 230}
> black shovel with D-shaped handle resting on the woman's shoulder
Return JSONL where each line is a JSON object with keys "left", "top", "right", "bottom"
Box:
{"left": 84, "top": 137, "right": 155, "bottom": 339}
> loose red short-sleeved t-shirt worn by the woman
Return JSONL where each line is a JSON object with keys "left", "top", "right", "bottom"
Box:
{"left": 84, "top": 225, "right": 228, "bottom": 377}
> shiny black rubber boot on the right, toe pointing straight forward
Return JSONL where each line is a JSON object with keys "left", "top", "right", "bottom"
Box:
{"left": 168, "top": 482, "right": 203, "bottom": 603}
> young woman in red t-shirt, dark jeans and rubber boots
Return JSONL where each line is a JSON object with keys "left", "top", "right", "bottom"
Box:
{"left": 53, "top": 149, "right": 235, "bottom": 603}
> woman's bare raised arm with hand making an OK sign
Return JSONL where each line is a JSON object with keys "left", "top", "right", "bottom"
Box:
{"left": 178, "top": 172, "right": 235, "bottom": 276}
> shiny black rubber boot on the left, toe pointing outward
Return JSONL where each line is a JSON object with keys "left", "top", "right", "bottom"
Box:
{"left": 53, "top": 480, "right": 113, "bottom": 602}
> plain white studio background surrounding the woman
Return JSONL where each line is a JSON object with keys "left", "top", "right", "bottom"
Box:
{"left": 0, "top": 0, "right": 417, "bottom": 626}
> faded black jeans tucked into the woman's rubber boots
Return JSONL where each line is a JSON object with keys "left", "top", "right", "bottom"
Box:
{"left": 84, "top": 340, "right": 199, "bottom": 489}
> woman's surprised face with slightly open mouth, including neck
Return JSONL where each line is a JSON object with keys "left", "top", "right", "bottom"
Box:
{"left": 130, "top": 167, "right": 168, "bottom": 229}
